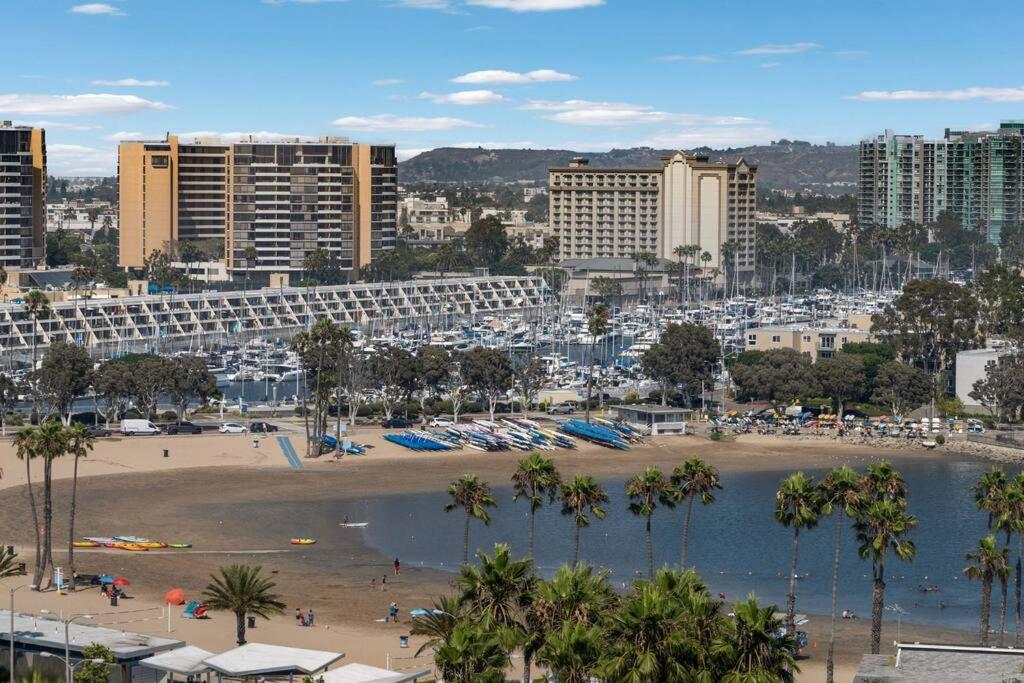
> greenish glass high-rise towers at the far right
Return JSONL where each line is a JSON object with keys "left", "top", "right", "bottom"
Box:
{"left": 857, "top": 122, "right": 1024, "bottom": 244}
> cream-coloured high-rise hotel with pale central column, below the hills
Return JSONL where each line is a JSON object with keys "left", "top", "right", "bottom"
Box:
{"left": 548, "top": 152, "right": 757, "bottom": 273}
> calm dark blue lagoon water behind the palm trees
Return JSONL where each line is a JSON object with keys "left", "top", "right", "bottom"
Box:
{"left": 354, "top": 456, "right": 1013, "bottom": 629}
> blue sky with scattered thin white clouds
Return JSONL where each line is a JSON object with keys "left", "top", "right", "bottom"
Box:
{"left": 0, "top": 0, "right": 1024, "bottom": 175}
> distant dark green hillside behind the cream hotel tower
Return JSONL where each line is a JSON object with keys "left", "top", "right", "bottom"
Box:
{"left": 398, "top": 140, "right": 857, "bottom": 194}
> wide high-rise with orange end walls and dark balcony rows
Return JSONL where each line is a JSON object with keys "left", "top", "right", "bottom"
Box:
{"left": 119, "top": 135, "right": 397, "bottom": 274}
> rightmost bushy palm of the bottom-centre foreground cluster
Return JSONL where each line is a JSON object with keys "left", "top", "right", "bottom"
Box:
{"left": 714, "top": 595, "right": 800, "bottom": 683}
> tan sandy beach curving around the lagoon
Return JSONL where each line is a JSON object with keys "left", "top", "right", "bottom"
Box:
{"left": 0, "top": 429, "right": 972, "bottom": 681}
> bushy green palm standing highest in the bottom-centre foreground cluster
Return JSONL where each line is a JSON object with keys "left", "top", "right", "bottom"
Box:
{"left": 456, "top": 544, "right": 543, "bottom": 683}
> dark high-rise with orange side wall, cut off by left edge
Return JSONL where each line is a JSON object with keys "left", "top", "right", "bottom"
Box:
{"left": 0, "top": 121, "right": 46, "bottom": 271}
